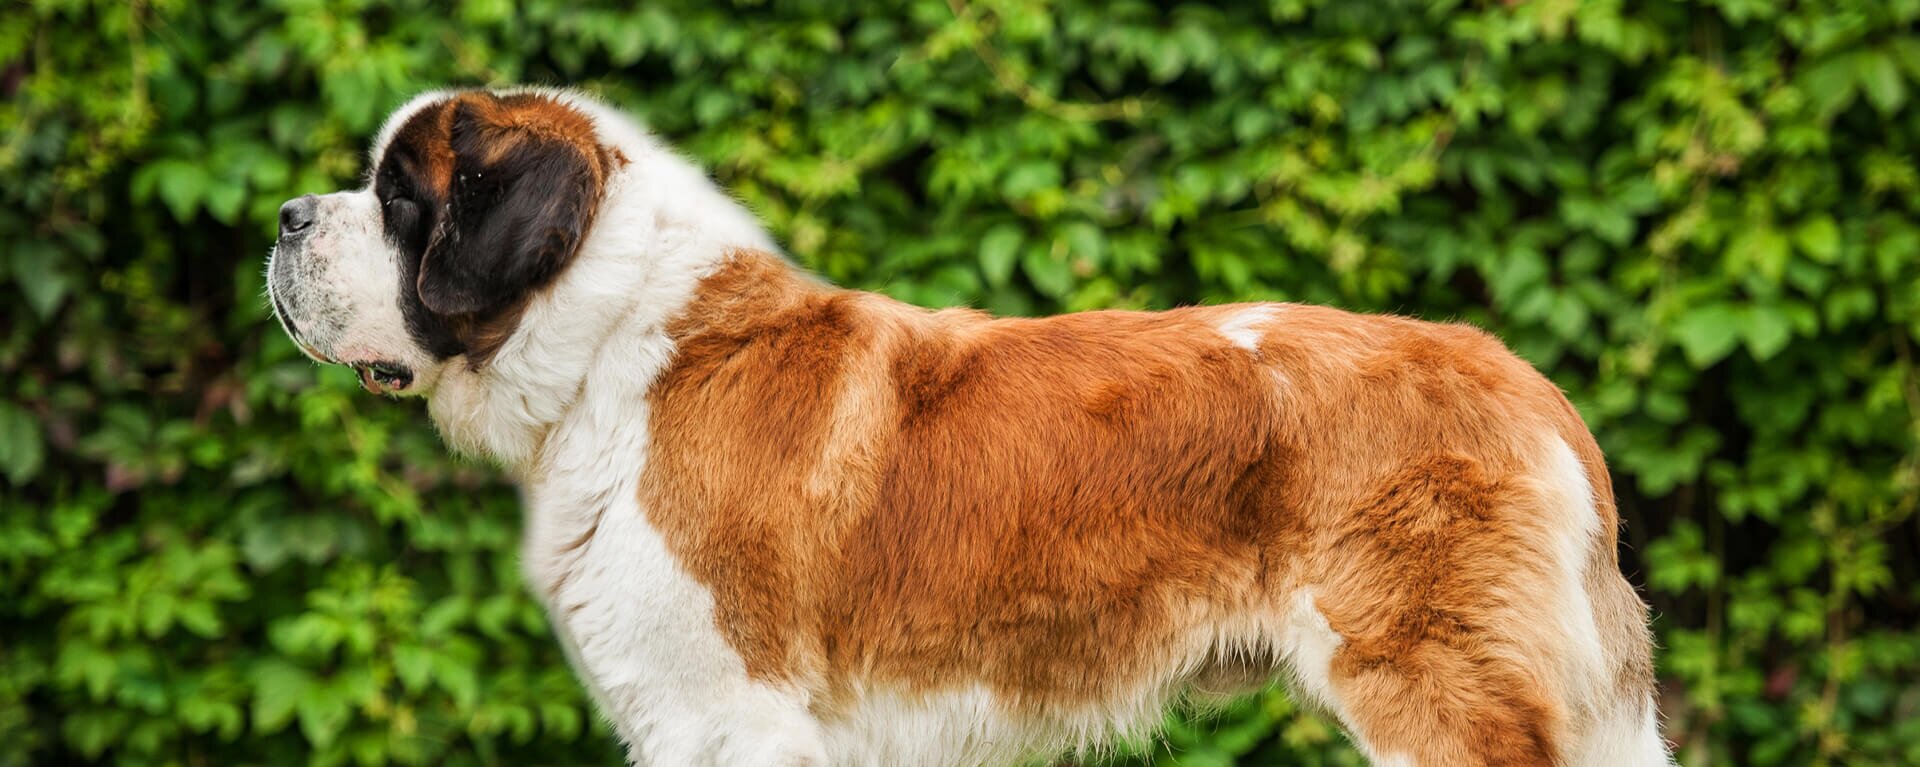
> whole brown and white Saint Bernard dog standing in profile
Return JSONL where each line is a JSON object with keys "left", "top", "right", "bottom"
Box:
{"left": 267, "top": 88, "right": 1670, "bottom": 767}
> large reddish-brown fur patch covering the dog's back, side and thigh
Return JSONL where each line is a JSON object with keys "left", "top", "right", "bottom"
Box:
{"left": 639, "top": 254, "right": 1645, "bottom": 765}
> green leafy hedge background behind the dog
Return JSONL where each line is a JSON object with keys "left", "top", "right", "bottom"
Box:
{"left": 0, "top": 0, "right": 1920, "bottom": 765}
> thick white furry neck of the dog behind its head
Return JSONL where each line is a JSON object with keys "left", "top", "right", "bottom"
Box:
{"left": 428, "top": 127, "right": 776, "bottom": 482}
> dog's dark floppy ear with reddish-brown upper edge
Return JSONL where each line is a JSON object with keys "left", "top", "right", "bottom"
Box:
{"left": 417, "top": 96, "right": 605, "bottom": 317}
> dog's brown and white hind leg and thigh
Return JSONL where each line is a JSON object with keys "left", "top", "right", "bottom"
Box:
{"left": 1283, "top": 440, "right": 1670, "bottom": 767}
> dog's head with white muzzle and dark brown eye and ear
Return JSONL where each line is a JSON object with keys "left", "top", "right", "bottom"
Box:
{"left": 267, "top": 90, "right": 618, "bottom": 394}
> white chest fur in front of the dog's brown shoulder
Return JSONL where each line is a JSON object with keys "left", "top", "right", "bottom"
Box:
{"left": 522, "top": 326, "right": 824, "bottom": 765}
